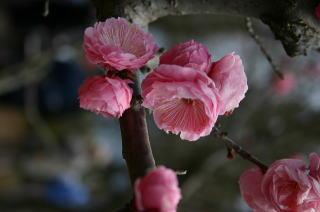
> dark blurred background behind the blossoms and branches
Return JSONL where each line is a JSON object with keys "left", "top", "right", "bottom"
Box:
{"left": 0, "top": 0, "right": 320, "bottom": 212}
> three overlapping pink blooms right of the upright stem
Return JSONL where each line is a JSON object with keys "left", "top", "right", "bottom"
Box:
{"left": 141, "top": 40, "right": 248, "bottom": 141}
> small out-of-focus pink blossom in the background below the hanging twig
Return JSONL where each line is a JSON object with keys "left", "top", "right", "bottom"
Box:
{"left": 272, "top": 73, "right": 297, "bottom": 96}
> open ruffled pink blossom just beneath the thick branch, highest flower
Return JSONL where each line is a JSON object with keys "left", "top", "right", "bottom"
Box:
{"left": 83, "top": 18, "right": 158, "bottom": 71}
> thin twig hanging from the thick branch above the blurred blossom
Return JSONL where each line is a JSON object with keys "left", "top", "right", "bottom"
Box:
{"left": 246, "top": 17, "right": 284, "bottom": 79}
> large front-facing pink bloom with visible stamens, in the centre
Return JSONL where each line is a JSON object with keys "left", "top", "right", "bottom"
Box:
{"left": 142, "top": 65, "right": 219, "bottom": 141}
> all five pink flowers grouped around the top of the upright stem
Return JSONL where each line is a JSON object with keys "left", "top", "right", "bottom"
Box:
{"left": 79, "top": 18, "right": 248, "bottom": 141}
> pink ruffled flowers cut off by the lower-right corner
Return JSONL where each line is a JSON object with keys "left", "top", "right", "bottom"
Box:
{"left": 239, "top": 153, "right": 320, "bottom": 212}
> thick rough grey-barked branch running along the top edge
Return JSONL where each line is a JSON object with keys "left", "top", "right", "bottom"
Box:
{"left": 93, "top": 0, "right": 320, "bottom": 56}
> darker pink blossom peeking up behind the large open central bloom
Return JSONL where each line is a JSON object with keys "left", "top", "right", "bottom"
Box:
{"left": 160, "top": 40, "right": 211, "bottom": 72}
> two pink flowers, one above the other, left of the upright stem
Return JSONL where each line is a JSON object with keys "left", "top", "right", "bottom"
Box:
{"left": 79, "top": 18, "right": 158, "bottom": 118}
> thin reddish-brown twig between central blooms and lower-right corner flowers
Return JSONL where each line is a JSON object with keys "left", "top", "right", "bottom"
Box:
{"left": 213, "top": 127, "right": 268, "bottom": 173}
